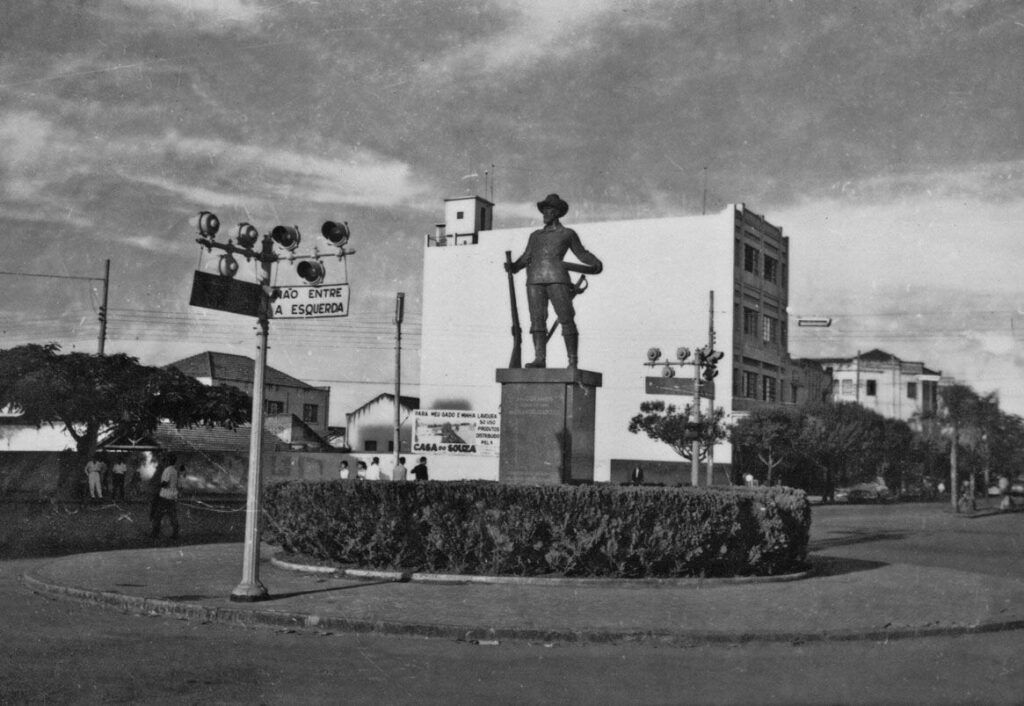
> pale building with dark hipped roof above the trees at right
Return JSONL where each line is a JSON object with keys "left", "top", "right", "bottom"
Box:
{"left": 815, "top": 348, "right": 942, "bottom": 421}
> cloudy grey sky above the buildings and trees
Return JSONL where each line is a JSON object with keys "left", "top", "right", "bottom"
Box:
{"left": 0, "top": 0, "right": 1024, "bottom": 425}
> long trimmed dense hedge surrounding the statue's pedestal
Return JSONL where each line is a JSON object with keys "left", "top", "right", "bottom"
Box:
{"left": 263, "top": 481, "right": 811, "bottom": 578}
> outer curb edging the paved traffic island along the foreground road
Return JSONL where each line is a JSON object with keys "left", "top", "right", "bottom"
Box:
{"left": 22, "top": 574, "right": 1024, "bottom": 647}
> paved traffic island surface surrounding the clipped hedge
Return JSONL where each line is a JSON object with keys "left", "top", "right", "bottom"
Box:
{"left": 24, "top": 544, "right": 1024, "bottom": 645}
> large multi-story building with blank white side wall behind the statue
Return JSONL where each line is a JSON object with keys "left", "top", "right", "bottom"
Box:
{"left": 420, "top": 197, "right": 804, "bottom": 481}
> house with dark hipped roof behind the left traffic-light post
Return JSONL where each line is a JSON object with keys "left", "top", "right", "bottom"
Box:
{"left": 167, "top": 350, "right": 331, "bottom": 440}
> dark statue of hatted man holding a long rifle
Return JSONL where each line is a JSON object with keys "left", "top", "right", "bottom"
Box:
{"left": 505, "top": 194, "right": 603, "bottom": 369}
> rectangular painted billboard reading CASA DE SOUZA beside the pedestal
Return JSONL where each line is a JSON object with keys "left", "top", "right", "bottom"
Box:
{"left": 413, "top": 410, "right": 501, "bottom": 456}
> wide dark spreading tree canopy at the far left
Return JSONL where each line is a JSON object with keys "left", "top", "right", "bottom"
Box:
{"left": 0, "top": 343, "right": 252, "bottom": 454}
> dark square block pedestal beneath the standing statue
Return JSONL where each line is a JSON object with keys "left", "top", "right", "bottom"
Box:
{"left": 497, "top": 368, "right": 601, "bottom": 485}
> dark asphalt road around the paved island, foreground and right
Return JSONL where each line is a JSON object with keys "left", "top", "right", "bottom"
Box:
{"left": 0, "top": 506, "right": 1024, "bottom": 704}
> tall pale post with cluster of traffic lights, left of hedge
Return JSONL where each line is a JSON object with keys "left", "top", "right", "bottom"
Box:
{"left": 191, "top": 211, "right": 355, "bottom": 603}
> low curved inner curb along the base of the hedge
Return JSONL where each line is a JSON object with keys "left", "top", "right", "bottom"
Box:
{"left": 270, "top": 552, "right": 814, "bottom": 588}
